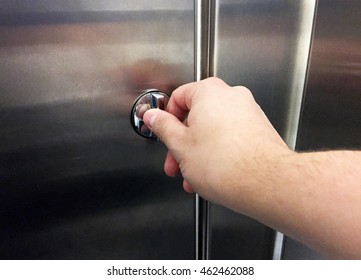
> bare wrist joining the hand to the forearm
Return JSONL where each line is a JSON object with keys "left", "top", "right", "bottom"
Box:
{"left": 222, "top": 146, "right": 299, "bottom": 220}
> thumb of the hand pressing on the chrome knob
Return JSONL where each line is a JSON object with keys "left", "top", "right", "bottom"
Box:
{"left": 143, "top": 109, "right": 186, "bottom": 151}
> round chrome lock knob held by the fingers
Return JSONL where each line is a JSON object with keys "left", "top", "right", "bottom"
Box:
{"left": 130, "top": 89, "right": 169, "bottom": 140}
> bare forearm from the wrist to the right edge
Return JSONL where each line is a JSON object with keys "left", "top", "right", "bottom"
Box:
{"left": 254, "top": 151, "right": 361, "bottom": 258}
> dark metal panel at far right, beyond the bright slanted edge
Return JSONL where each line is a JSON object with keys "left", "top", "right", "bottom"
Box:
{"left": 284, "top": 0, "right": 361, "bottom": 259}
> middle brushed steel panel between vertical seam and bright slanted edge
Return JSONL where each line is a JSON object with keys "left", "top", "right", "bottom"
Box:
{"left": 210, "top": 0, "right": 315, "bottom": 259}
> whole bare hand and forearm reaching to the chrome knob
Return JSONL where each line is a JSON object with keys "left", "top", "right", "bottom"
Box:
{"left": 144, "top": 78, "right": 361, "bottom": 259}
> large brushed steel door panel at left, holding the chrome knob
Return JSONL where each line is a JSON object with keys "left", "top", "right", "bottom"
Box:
{"left": 0, "top": 0, "right": 195, "bottom": 259}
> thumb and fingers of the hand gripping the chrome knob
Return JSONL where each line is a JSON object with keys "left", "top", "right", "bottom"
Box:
{"left": 143, "top": 78, "right": 229, "bottom": 196}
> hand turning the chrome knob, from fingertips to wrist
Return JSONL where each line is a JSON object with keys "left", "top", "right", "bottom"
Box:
{"left": 144, "top": 78, "right": 291, "bottom": 213}
